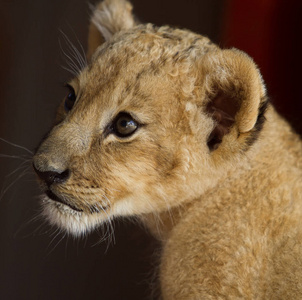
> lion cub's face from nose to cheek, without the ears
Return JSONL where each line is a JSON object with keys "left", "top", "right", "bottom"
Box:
{"left": 34, "top": 28, "right": 217, "bottom": 233}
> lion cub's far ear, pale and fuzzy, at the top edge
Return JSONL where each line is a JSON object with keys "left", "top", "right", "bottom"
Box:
{"left": 87, "top": 0, "right": 136, "bottom": 59}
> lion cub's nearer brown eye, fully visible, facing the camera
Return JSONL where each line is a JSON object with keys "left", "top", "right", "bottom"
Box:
{"left": 112, "top": 113, "right": 138, "bottom": 137}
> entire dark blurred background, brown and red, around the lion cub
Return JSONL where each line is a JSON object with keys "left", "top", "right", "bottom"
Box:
{"left": 0, "top": 0, "right": 302, "bottom": 300}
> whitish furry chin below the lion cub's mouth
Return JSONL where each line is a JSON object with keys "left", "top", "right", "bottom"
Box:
{"left": 42, "top": 195, "right": 110, "bottom": 237}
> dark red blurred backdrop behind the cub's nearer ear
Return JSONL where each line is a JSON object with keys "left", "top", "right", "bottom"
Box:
{"left": 223, "top": 0, "right": 302, "bottom": 134}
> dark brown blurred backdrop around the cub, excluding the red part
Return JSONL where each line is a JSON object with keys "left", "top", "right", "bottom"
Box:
{"left": 0, "top": 0, "right": 224, "bottom": 300}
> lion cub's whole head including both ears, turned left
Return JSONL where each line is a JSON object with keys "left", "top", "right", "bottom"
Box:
{"left": 33, "top": 0, "right": 265, "bottom": 234}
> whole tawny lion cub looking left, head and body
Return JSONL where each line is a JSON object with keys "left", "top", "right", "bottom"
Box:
{"left": 33, "top": 0, "right": 302, "bottom": 299}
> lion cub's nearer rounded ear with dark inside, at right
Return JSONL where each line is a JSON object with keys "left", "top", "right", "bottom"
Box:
{"left": 200, "top": 49, "right": 267, "bottom": 152}
